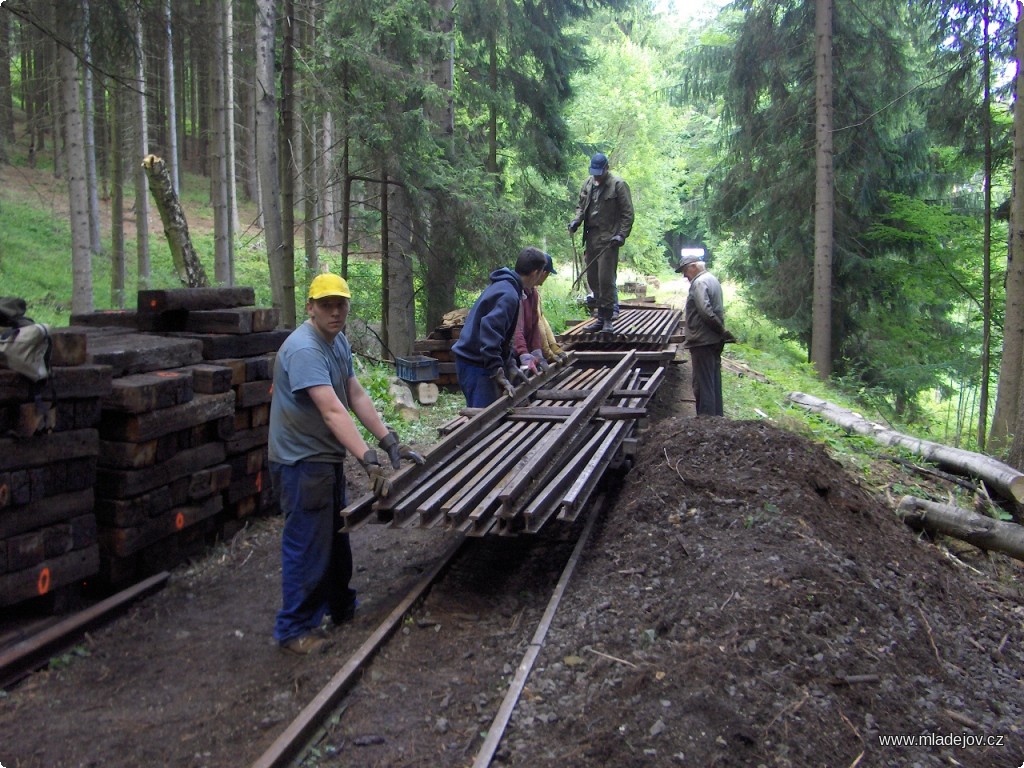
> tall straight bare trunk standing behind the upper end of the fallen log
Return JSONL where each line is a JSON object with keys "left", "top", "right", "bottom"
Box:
{"left": 811, "top": 0, "right": 835, "bottom": 381}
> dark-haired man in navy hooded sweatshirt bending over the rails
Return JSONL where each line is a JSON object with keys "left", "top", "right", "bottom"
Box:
{"left": 452, "top": 246, "right": 548, "bottom": 408}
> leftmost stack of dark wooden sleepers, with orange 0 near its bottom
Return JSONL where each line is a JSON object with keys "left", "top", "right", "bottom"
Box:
{"left": 0, "top": 329, "right": 112, "bottom": 606}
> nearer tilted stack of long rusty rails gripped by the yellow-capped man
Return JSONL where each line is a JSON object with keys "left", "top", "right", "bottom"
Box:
{"left": 342, "top": 351, "right": 666, "bottom": 536}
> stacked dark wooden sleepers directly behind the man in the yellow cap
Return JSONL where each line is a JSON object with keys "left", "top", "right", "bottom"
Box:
{"left": 72, "top": 288, "right": 288, "bottom": 584}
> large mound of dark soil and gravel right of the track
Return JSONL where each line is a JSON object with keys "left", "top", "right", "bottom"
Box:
{"left": 508, "top": 418, "right": 1024, "bottom": 766}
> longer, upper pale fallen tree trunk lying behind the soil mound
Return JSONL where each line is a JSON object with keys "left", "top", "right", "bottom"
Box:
{"left": 788, "top": 392, "right": 1024, "bottom": 503}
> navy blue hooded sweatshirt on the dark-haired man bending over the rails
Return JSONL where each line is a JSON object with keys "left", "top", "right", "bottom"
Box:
{"left": 452, "top": 266, "right": 523, "bottom": 372}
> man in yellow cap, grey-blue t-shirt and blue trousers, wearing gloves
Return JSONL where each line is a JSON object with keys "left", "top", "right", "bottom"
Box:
{"left": 268, "top": 273, "right": 424, "bottom": 654}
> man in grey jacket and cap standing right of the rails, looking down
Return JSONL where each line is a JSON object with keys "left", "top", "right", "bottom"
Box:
{"left": 676, "top": 254, "right": 735, "bottom": 416}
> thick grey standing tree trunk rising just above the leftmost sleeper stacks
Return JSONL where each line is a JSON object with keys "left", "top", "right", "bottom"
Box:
{"left": 58, "top": 7, "right": 92, "bottom": 314}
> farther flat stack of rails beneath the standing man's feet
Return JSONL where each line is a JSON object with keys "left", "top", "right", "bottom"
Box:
{"left": 557, "top": 303, "right": 683, "bottom": 350}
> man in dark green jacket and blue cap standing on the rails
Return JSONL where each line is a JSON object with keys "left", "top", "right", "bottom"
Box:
{"left": 569, "top": 153, "right": 633, "bottom": 333}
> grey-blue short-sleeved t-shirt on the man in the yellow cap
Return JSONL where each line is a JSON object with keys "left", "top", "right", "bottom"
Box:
{"left": 267, "top": 321, "right": 355, "bottom": 466}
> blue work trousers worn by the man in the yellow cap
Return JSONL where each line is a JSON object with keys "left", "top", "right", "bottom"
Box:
{"left": 270, "top": 462, "right": 355, "bottom": 643}
